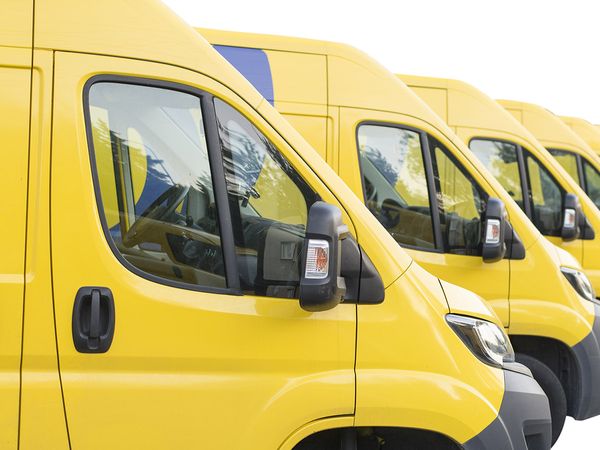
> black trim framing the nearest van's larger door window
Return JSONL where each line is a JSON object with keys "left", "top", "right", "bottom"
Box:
{"left": 82, "top": 74, "right": 242, "bottom": 296}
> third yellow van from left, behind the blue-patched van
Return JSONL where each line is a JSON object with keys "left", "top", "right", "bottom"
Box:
{"left": 401, "top": 75, "right": 600, "bottom": 292}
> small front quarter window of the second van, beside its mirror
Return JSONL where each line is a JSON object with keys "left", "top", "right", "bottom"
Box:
{"left": 429, "top": 136, "right": 487, "bottom": 256}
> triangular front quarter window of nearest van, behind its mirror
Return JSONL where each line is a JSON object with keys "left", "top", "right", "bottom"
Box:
{"left": 214, "top": 99, "right": 319, "bottom": 298}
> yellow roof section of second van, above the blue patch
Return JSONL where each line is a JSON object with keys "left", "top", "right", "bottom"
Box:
{"left": 198, "top": 28, "right": 447, "bottom": 130}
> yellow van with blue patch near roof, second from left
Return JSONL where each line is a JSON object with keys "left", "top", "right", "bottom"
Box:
{"left": 200, "top": 30, "right": 600, "bottom": 439}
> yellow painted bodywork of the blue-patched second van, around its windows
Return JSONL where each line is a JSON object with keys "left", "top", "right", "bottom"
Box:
{"left": 200, "top": 30, "right": 593, "bottom": 368}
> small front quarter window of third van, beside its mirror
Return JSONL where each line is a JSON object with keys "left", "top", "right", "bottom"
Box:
{"left": 524, "top": 151, "right": 564, "bottom": 236}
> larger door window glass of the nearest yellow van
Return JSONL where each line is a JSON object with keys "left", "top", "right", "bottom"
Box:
{"left": 88, "top": 82, "right": 227, "bottom": 288}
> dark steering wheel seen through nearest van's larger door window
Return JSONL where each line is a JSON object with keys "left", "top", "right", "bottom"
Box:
{"left": 123, "top": 184, "right": 190, "bottom": 247}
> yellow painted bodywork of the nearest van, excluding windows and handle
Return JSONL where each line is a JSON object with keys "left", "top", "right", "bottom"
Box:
{"left": 0, "top": 0, "right": 504, "bottom": 449}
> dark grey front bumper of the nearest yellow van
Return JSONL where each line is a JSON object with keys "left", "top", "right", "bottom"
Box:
{"left": 463, "top": 363, "right": 552, "bottom": 450}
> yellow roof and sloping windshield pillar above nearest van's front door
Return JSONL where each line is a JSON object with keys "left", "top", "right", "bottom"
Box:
{"left": 25, "top": 0, "right": 411, "bottom": 283}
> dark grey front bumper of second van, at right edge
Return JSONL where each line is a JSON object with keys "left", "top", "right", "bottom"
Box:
{"left": 569, "top": 304, "right": 600, "bottom": 420}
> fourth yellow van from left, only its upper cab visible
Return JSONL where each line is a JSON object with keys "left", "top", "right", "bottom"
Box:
{"left": 497, "top": 100, "right": 600, "bottom": 208}
